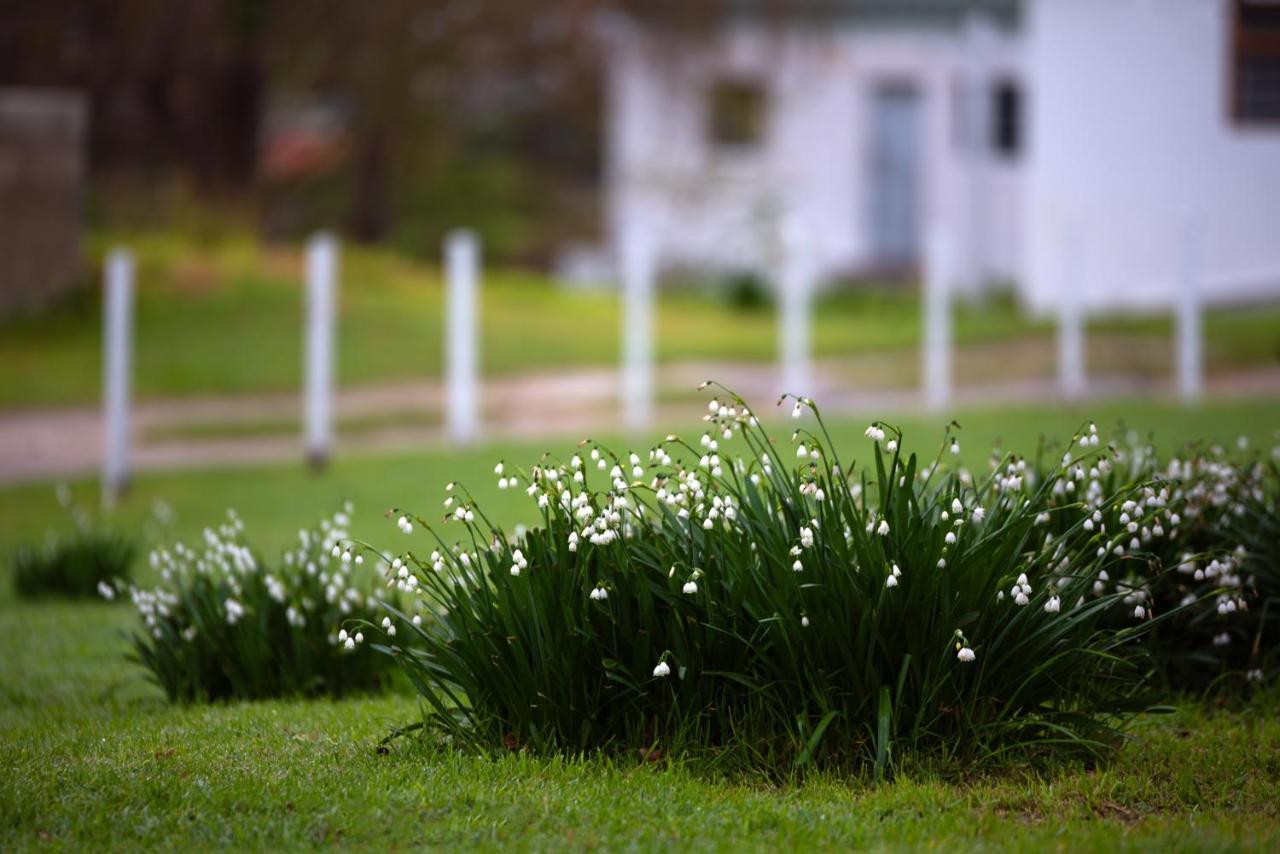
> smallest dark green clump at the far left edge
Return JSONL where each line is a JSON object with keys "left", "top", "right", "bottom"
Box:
{"left": 13, "top": 490, "right": 134, "bottom": 598}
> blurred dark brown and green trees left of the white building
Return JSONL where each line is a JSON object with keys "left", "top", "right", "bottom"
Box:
{"left": 0, "top": 0, "right": 793, "bottom": 257}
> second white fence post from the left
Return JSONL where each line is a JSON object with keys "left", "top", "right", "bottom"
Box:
{"left": 303, "top": 232, "right": 338, "bottom": 469}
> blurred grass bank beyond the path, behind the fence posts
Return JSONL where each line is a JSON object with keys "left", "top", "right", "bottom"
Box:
{"left": 0, "top": 234, "right": 1280, "bottom": 408}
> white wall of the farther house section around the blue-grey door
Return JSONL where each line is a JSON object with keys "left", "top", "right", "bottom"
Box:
{"left": 607, "top": 18, "right": 1021, "bottom": 286}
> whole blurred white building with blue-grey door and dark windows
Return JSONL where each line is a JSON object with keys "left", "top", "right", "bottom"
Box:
{"left": 605, "top": 0, "right": 1280, "bottom": 310}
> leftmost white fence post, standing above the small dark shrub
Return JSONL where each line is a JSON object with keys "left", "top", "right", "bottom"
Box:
{"left": 102, "top": 248, "right": 133, "bottom": 506}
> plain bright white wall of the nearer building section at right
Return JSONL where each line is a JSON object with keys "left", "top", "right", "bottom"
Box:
{"left": 1023, "top": 0, "right": 1280, "bottom": 310}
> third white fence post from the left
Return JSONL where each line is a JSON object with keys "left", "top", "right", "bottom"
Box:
{"left": 444, "top": 229, "right": 480, "bottom": 443}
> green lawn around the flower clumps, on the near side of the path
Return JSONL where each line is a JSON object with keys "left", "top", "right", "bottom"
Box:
{"left": 0, "top": 401, "right": 1280, "bottom": 851}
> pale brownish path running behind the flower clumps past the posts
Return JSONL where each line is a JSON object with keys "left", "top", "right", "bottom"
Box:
{"left": 0, "top": 353, "right": 1280, "bottom": 484}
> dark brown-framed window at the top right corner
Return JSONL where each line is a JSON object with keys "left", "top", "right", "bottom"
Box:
{"left": 1230, "top": 0, "right": 1280, "bottom": 122}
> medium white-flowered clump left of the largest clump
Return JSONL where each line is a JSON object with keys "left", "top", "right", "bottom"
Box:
{"left": 120, "top": 507, "right": 399, "bottom": 700}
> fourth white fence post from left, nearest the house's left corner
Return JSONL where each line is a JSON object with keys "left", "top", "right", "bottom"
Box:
{"left": 618, "top": 223, "right": 657, "bottom": 430}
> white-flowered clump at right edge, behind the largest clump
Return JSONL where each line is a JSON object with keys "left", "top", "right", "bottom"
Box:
{"left": 1024, "top": 437, "right": 1280, "bottom": 690}
